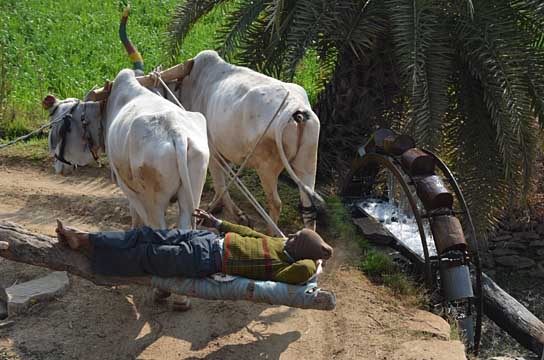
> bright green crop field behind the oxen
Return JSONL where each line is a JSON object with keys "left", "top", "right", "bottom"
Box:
{"left": 0, "top": 0, "right": 225, "bottom": 138}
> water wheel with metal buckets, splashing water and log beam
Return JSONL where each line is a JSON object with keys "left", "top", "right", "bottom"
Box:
{"left": 341, "top": 129, "right": 544, "bottom": 355}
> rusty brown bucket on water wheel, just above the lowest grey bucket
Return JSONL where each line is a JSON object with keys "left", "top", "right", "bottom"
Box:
{"left": 431, "top": 215, "right": 467, "bottom": 255}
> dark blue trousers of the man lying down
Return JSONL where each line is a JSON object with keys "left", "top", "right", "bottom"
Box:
{"left": 89, "top": 227, "right": 223, "bottom": 277}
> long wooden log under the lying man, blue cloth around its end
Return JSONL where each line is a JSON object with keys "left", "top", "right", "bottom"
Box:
{"left": 0, "top": 222, "right": 336, "bottom": 310}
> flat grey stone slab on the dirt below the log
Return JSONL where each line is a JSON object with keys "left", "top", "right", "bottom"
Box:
{"left": 0, "top": 271, "right": 70, "bottom": 316}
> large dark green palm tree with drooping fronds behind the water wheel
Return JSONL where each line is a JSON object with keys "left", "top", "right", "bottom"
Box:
{"left": 169, "top": 0, "right": 544, "bottom": 235}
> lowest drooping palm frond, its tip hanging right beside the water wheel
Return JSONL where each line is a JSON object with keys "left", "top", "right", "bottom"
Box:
{"left": 443, "top": 67, "right": 519, "bottom": 239}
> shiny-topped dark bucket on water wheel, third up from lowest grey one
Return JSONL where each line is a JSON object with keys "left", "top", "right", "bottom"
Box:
{"left": 415, "top": 175, "right": 453, "bottom": 211}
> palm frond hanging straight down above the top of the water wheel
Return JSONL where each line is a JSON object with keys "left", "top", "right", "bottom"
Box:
{"left": 388, "top": 0, "right": 453, "bottom": 149}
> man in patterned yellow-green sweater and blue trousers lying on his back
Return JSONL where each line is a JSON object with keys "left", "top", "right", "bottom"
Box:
{"left": 56, "top": 209, "right": 332, "bottom": 284}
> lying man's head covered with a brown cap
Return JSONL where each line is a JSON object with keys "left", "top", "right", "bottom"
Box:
{"left": 285, "top": 229, "right": 332, "bottom": 261}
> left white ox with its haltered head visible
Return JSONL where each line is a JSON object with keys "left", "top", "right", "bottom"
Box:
{"left": 43, "top": 69, "right": 209, "bottom": 228}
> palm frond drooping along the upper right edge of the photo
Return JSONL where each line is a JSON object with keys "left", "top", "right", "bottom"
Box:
{"left": 457, "top": 4, "right": 536, "bottom": 186}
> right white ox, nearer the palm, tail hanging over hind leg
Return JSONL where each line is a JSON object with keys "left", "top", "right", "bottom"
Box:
{"left": 164, "top": 50, "right": 324, "bottom": 228}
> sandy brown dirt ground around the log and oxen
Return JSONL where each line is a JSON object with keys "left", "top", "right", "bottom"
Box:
{"left": 0, "top": 159, "right": 464, "bottom": 360}
